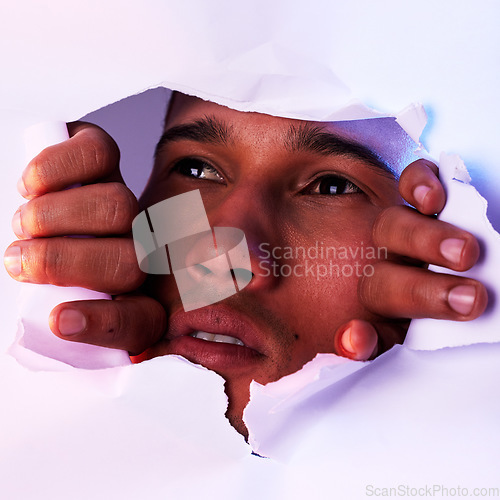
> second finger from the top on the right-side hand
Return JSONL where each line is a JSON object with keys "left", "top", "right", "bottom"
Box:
{"left": 373, "top": 206, "right": 480, "bottom": 271}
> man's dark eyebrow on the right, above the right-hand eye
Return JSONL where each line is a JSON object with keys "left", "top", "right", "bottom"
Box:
{"left": 285, "top": 122, "right": 396, "bottom": 179}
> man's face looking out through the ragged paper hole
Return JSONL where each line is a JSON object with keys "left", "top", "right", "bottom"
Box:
{"left": 141, "top": 95, "right": 400, "bottom": 433}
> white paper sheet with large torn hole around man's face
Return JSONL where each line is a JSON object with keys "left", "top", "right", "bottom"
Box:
{"left": 0, "top": 0, "right": 500, "bottom": 500}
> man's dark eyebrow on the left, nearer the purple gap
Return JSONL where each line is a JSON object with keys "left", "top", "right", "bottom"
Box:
{"left": 155, "top": 116, "right": 232, "bottom": 156}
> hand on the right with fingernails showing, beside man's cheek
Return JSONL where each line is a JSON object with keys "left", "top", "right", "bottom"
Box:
{"left": 336, "top": 160, "right": 488, "bottom": 360}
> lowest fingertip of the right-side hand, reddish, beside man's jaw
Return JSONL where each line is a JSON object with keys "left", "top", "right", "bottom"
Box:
{"left": 335, "top": 319, "right": 378, "bottom": 361}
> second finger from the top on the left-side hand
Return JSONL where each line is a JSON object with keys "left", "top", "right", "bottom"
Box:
{"left": 12, "top": 182, "right": 138, "bottom": 239}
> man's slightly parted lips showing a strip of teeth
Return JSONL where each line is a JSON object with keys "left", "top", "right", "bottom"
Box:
{"left": 166, "top": 305, "right": 265, "bottom": 373}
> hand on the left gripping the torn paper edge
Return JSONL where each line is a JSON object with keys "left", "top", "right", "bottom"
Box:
{"left": 5, "top": 123, "right": 166, "bottom": 354}
